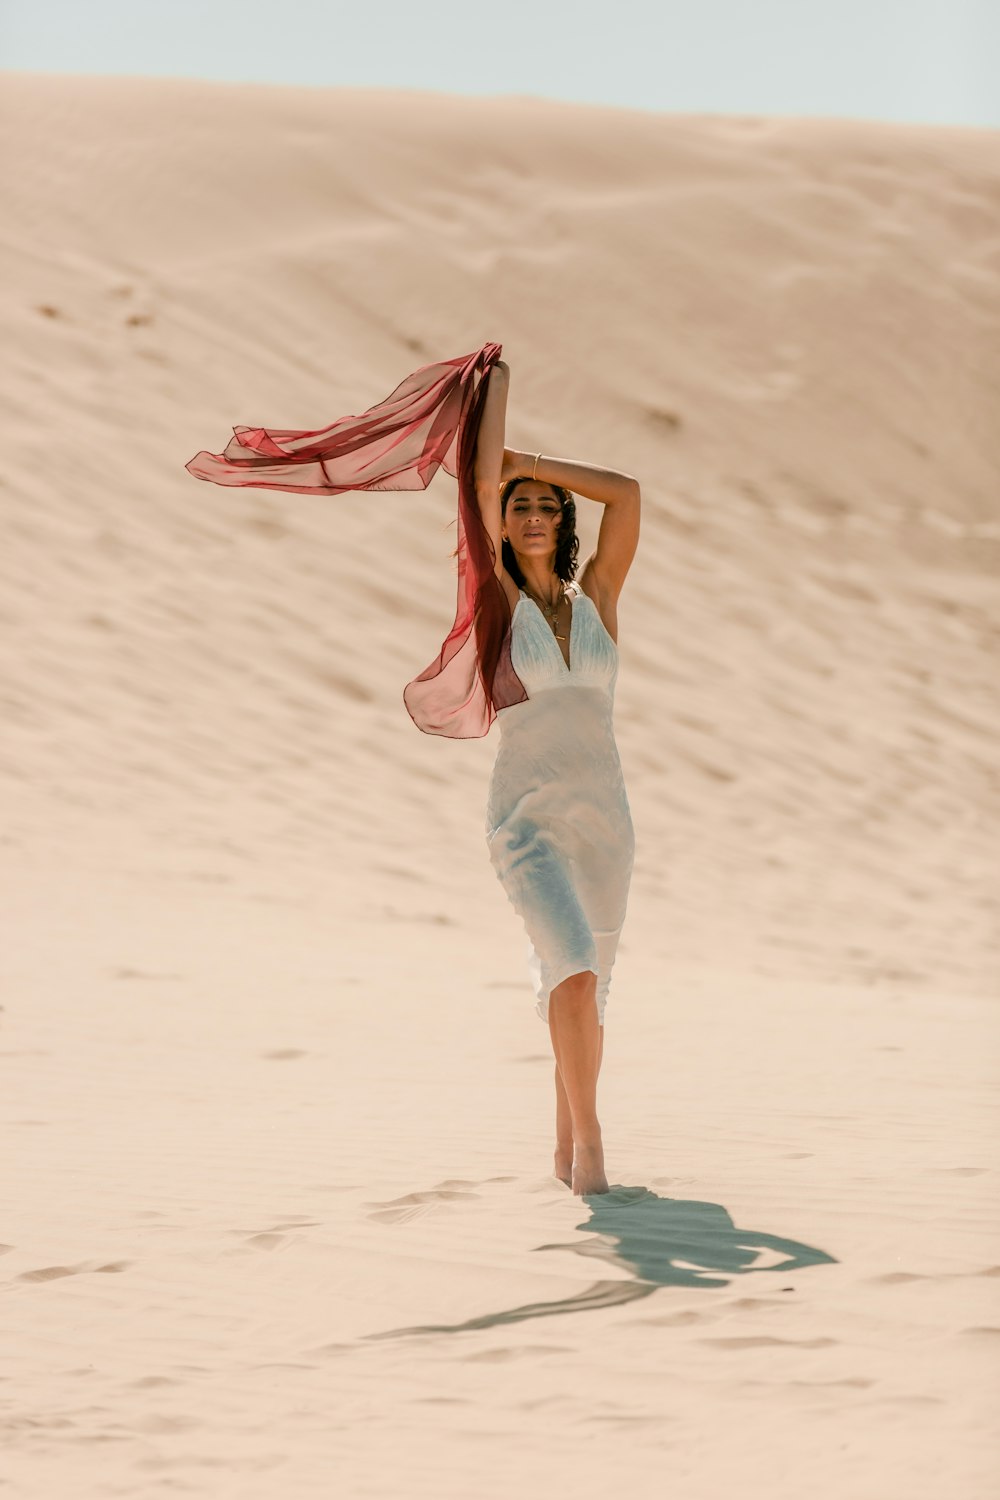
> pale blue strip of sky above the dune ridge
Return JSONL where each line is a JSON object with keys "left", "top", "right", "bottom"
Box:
{"left": 0, "top": 0, "right": 1000, "bottom": 128}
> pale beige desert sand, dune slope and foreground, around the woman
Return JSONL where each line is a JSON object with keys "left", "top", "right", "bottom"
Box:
{"left": 0, "top": 75, "right": 1000, "bottom": 1500}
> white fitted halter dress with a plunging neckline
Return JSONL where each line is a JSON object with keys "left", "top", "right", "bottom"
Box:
{"left": 486, "top": 582, "right": 636, "bottom": 1025}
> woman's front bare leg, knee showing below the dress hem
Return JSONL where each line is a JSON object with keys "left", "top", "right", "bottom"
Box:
{"left": 549, "top": 971, "right": 607, "bottom": 1194}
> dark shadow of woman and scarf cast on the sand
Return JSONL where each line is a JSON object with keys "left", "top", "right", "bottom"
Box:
{"left": 366, "top": 1185, "right": 837, "bottom": 1340}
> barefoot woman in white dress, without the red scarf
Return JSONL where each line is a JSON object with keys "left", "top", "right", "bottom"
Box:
{"left": 475, "top": 360, "right": 640, "bottom": 1194}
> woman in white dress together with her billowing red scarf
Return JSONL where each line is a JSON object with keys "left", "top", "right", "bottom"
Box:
{"left": 184, "top": 341, "right": 640, "bottom": 1194}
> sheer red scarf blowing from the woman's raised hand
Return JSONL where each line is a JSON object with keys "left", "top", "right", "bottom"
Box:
{"left": 184, "top": 344, "right": 528, "bottom": 740}
